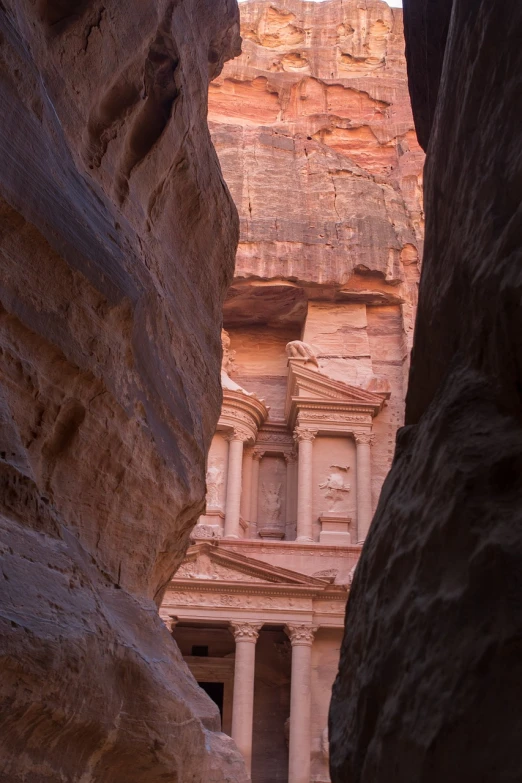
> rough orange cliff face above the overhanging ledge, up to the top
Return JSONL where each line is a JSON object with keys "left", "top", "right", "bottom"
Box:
{"left": 209, "top": 0, "right": 424, "bottom": 292}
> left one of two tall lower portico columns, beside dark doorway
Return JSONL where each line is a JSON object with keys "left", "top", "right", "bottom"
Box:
{"left": 230, "top": 622, "right": 263, "bottom": 775}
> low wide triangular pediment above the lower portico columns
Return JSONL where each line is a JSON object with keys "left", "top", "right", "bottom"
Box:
{"left": 173, "top": 542, "right": 328, "bottom": 588}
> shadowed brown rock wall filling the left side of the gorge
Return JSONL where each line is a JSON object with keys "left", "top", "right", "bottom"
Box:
{"left": 0, "top": 0, "right": 245, "bottom": 783}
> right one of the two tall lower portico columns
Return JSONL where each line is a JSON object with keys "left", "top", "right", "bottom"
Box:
{"left": 285, "top": 625, "right": 317, "bottom": 783}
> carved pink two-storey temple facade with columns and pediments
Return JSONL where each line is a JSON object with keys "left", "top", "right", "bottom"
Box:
{"left": 162, "top": 323, "right": 398, "bottom": 783}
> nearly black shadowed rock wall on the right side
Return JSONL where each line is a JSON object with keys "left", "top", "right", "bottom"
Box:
{"left": 330, "top": 0, "right": 522, "bottom": 783}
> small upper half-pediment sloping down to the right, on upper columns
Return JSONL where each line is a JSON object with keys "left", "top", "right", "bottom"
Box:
{"left": 286, "top": 361, "right": 384, "bottom": 419}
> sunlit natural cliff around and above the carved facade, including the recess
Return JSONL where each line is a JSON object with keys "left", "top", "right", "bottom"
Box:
{"left": 209, "top": 0, "right": 424, "bottom": 506}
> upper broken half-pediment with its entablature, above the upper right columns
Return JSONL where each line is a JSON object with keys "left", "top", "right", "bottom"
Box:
{"left": 285, "top": 359, "right": 386, "bottom": 427}
